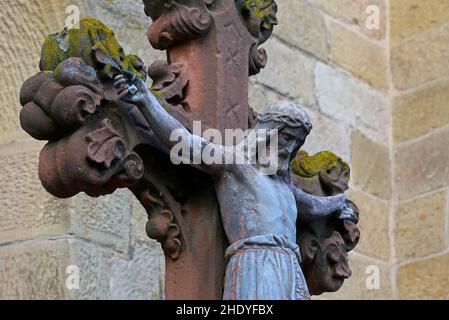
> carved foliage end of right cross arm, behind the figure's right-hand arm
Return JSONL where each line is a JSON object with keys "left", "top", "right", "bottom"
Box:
{"left": 292, "top": 151, "right": 360, "bottom": 295}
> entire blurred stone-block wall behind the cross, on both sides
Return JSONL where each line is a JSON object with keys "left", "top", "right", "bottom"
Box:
{"left": 0, "top": 0, "right": 449, "bottom": 299}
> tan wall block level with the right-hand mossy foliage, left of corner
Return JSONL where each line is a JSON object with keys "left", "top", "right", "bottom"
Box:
{"left": 351, "top": 130, "right": 391, "bottom": 199}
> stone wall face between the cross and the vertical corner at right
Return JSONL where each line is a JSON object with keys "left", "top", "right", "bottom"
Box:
{"left": 252, "top": 0, "right": 395, "bottom": 299}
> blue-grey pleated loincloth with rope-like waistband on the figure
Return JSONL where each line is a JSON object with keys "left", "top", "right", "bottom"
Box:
{"left": 223, "top": 234, "right": 310, "bottom": 300}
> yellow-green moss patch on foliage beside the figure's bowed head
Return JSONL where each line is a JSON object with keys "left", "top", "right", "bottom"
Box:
{"left": 291, "top": 151, "right": 349, "bottom": 178}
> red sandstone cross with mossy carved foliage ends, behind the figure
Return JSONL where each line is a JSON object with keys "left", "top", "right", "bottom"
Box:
{"left": 20, "top": 0, "right": 359, "bottom": 299}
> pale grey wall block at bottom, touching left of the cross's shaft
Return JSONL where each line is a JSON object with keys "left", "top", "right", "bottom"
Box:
{"left": 111, "top": 240, "right": 165, "bottom": 300}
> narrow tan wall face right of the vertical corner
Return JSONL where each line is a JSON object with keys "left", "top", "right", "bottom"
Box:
{"left": 390, "top": 0, "right": 449, "bottom": 299}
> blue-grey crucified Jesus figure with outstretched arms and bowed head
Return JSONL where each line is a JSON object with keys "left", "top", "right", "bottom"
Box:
{"left": 115, "top": 73, "right": 346, "bottom": 300}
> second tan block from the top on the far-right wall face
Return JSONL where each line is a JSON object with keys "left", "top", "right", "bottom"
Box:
{"left": 391, "top": 24, "right": 449, "bottom": 90}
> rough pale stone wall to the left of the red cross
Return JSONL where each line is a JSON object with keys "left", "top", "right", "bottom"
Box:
{"left": 0, "top": 0, "right": 165, "bottom": 299}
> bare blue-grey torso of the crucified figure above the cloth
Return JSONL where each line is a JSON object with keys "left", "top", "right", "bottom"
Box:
{"left": 215, "top": 165, "right": 297, "bottom": 243}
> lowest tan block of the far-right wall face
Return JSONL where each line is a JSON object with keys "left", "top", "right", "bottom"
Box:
{"left": 397, "top": 254, "right": 449, "bottom": 300}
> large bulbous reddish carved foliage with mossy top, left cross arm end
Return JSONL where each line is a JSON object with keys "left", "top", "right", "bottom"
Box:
{"left": 20, "top": 19, "right": 146, "bottom": 198}
